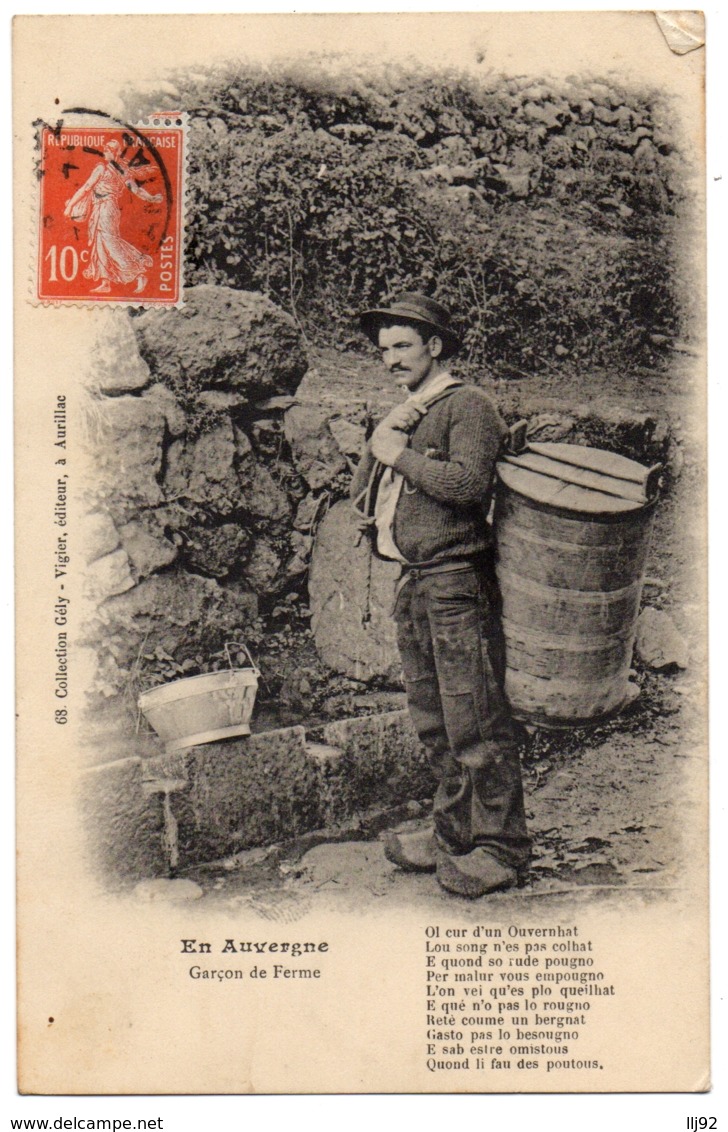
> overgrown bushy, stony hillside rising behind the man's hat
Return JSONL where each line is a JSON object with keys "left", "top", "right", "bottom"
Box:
{"left": 125, "top": 65, "right": 687, "bottom": 374}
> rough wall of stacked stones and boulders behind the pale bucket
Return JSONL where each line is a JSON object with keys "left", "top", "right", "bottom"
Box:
{"left": 84, "top": 285, "right": 371, "bottom": 713}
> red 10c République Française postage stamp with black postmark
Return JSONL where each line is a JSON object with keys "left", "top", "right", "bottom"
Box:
{"left": 34, "top": 114, "right": 186, "bottom": 307}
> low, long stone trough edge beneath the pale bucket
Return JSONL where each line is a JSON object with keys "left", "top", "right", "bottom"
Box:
{"left": 80, "top": 711, "right": 434, "bottom": 886}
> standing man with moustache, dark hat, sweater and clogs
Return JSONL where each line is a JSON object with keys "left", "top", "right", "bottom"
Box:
{"left": 352, "top": 293, "right": 530, "bottom": 897}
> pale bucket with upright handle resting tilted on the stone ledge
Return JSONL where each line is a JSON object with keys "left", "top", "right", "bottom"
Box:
{"left": 138, "top": 645, "right": 260, "bottom": 753}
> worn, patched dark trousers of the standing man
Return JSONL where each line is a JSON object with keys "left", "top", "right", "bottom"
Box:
{"left": 394, "top": 565, "right": 530, "bottom": 868}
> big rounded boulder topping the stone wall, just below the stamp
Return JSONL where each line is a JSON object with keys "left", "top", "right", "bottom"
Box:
{"left": 135, "top": 284, "right": 308, "bottom": 401}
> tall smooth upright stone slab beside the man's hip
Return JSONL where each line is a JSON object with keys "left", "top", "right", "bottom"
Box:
{"left": 308, "top": 500, "right": 400, "bottom": 681}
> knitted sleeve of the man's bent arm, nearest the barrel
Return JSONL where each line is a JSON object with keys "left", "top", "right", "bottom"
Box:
{"left": 393, "top": 387, "right": 507, "bottom": 507}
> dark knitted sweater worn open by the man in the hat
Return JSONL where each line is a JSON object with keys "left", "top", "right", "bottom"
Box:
{"left": 351, "top": 385, "right": 507, "bottom": 565}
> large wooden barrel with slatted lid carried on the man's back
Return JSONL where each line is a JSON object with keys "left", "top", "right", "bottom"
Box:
{"left": 495, "top": 444, "right": 659, "bottom": 727}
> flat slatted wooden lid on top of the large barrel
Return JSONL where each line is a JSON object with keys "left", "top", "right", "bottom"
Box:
{"left": 496, "top": 443, "right": 660, "bottom": 515}
